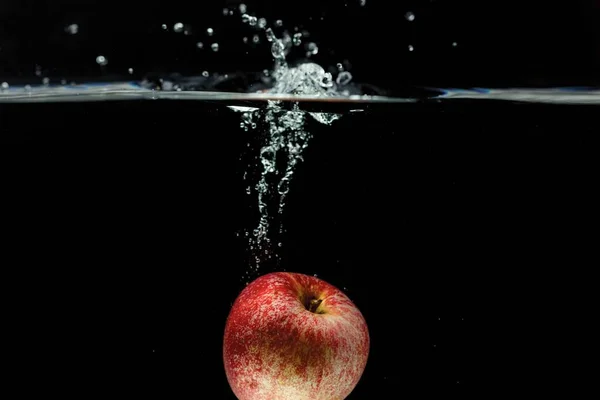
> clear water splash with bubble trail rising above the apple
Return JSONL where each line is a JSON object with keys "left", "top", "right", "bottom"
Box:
{"left": 238, "top": 10, "right": 344, "bottom": 279}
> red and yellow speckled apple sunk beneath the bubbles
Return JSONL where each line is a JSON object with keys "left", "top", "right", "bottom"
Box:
{"left": 223, "top": 272, "right": 370, "bottom": 400}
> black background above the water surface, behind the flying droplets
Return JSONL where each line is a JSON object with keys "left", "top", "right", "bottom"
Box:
{"left": 0, "top": 0, "right": 600, "bottom": 89}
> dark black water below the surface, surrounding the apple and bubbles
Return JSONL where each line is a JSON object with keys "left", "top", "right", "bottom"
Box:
{"left": 0, "top": 101, "right": 598, "bottom": 399}
